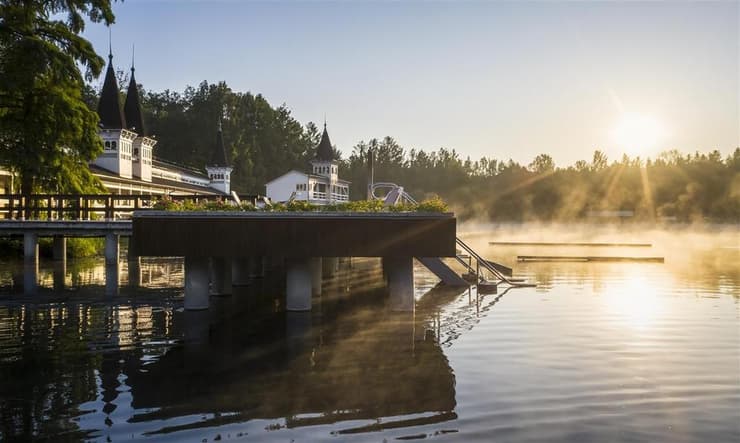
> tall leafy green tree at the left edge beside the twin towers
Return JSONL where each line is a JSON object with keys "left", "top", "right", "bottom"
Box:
{"left": 0, "top": 0, "right": 114, "bottom": 194}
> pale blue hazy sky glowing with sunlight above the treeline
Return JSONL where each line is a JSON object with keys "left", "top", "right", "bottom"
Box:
{"left": 86, "top": 0, "right": 740, "bottom": 166}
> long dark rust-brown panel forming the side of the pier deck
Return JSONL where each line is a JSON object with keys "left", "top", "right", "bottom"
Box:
{"left": 131, "top": 211, "right": 456, "bottom": 257}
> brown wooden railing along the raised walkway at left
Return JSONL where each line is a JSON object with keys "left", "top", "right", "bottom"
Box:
{"left": 0, "top": 194, "right": 246, "bottom": 220}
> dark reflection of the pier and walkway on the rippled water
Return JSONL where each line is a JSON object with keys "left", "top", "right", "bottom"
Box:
{"left": 0, "top": 261, "right": 492, "bottom": 440}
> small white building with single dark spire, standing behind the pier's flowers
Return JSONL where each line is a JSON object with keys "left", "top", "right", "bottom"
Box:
{"left": 265, "top": 124, "right": 350, "bottom": 205}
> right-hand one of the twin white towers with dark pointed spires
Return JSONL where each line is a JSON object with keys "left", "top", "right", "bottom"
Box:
{"left": 123, "top": 56, "right": 157, "bottom": 182}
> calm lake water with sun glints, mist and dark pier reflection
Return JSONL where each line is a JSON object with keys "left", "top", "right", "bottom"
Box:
{"left": 0, "top": 227, "right": 740, "bottom": 442}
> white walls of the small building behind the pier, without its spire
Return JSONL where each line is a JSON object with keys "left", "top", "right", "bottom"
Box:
{"left": 265, "top": 169, "right": 349, "bottom": 205}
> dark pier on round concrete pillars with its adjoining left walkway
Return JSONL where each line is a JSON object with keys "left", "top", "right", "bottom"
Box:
{"left": 0, "top": 207, "right": 467, "bottom": 311}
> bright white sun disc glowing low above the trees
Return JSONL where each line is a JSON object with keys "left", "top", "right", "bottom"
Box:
{"left": 612, "top": 113, "right": 665, "bottom": 156}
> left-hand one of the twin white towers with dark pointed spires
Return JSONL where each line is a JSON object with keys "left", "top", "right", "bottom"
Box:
{"left": 94, "top": 48, "right": 136, "bottom": 178}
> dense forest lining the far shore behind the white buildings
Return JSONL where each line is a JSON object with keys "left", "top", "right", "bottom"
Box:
{"left": 102, "top": 79, "right": 740, "bottom": 223}
